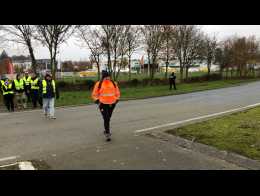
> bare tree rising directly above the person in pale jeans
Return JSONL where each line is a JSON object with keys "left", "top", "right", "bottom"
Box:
{"left": 36, "top": 25, "right": 75, "bottom": 78}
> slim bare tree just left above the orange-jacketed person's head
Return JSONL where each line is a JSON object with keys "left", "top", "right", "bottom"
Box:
{"left": 77, "top": 25, "right": 104, "bottom": 80}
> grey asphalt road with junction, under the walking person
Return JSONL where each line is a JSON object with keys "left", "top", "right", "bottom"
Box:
{"left": 0, "top": 82, "right": 260, "bottom": 169}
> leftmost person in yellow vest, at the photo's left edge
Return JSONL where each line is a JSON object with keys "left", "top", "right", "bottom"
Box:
{"left": 1, "top": 76, "right": 14, "bottom": 112}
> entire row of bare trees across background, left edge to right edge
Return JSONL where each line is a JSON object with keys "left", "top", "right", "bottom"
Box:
{"left": 0, "top": 25, "right": 259, "bottom": 80}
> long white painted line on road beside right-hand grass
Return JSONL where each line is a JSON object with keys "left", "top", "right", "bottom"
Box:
{"left": 134, "top": 103, "right": 260, "bottom": 133}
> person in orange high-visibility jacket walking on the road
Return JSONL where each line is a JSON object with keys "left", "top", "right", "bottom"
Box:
{"left": 92, "top": 71, "right": 120, "bottom": 141}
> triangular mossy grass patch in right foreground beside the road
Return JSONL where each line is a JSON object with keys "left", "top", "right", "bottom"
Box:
{"left": 168, "top": 107, "right": 260, "bottom": 160}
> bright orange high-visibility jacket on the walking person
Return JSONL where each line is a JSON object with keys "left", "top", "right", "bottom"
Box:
{"left": 92, "top": 80, "right": 120, "bottom": 104}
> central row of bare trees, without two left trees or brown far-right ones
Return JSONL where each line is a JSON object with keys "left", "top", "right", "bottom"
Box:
{"left": 76, "top": 25, "right": 217, "bottom": 80}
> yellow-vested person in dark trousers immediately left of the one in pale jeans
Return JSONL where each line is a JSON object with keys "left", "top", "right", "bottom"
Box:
{"left": 30, "top": 73, "right": 42, "bottom": 108}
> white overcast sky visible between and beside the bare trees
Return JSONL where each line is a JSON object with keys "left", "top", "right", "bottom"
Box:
{"left": 5, "top": 25, "right": 260, "bottom": 61}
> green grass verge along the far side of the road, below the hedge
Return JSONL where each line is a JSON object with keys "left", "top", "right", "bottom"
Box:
{"left": 56, "top": 79, "right": 255, "bottom": 106}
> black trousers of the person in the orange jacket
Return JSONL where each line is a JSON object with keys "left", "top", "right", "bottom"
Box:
{"left": 99, "top": 103, "right": 116, "bottom": 134}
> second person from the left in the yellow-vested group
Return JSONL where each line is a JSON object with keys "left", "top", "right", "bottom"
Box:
{"left": 13, "top": 73, "right": 27, "bottom": 109}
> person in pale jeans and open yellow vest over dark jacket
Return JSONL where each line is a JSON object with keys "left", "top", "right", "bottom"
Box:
{"left": 40, "top": 73, "right": 59, "bottom": 119}
